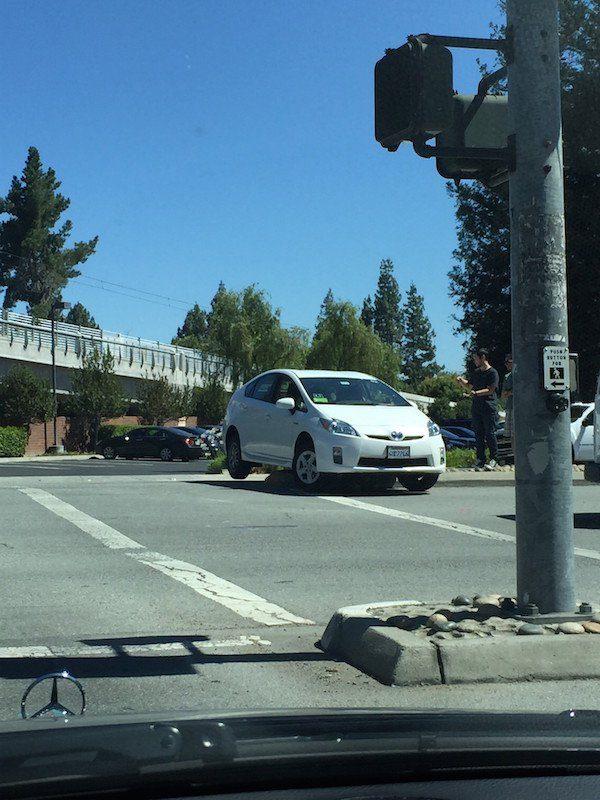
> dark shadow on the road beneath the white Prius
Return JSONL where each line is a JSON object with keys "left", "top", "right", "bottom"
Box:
{"left": 192, "top": 472, "right": 426, "bottom": 497}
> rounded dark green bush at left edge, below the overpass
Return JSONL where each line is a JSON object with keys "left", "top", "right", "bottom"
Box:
{"left": 0, "top": 366, "right": 54, "bottom": 425}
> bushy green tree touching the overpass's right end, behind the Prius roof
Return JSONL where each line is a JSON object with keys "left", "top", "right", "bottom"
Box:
{"left": 206, "top": 285, "right": 308, "bottom": 385}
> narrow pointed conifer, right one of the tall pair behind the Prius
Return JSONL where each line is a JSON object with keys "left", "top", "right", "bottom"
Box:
{"left": 402, "top": 283, "right": 440, "bottom": 386}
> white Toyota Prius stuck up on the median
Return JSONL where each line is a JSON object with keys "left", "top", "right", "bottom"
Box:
{"left": 223, "top": 369, "right": 446, "bottom": 492}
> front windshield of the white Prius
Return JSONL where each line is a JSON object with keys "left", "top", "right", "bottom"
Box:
{"left": 301, "top": 375, "right": 410, "bottom": 406}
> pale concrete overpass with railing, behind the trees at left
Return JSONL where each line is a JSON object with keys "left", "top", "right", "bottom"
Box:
{"left": 0, "top": 310, "right": 231, "bottom": 400}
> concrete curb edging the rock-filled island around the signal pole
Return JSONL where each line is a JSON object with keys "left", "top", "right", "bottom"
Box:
{"left": 319, "top": 601, "right": 600, "bottom": 686}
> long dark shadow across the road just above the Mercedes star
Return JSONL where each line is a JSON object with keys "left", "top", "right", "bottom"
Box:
{"left": 0, "top": 636, "right": 337, "bottom": 680}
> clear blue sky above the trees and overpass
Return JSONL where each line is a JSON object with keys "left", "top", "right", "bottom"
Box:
{"left": 0, "top": 0, "right": 498, "bottom": 368}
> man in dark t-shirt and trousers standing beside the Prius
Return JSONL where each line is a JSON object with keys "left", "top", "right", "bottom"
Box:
{"left": 458, "top": 347, "right": 500, "bottom": 470}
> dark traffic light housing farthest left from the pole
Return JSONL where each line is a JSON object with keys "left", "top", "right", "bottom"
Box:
{"left": 375, "top": 36, "right": 453, "bottom": 152}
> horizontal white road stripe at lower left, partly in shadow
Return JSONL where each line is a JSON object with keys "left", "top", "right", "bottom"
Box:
{"left": 0, "top": 636, "right": 271, "bottom": 659}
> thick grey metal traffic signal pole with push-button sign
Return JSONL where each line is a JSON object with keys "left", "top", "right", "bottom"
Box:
{"left": 507, "top": 0, "right": 576, "bottom": 614}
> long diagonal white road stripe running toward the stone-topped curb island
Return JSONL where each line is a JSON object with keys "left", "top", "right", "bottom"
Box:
{"left": 20, "top": 488, "right": 315, "bottom": 625}
